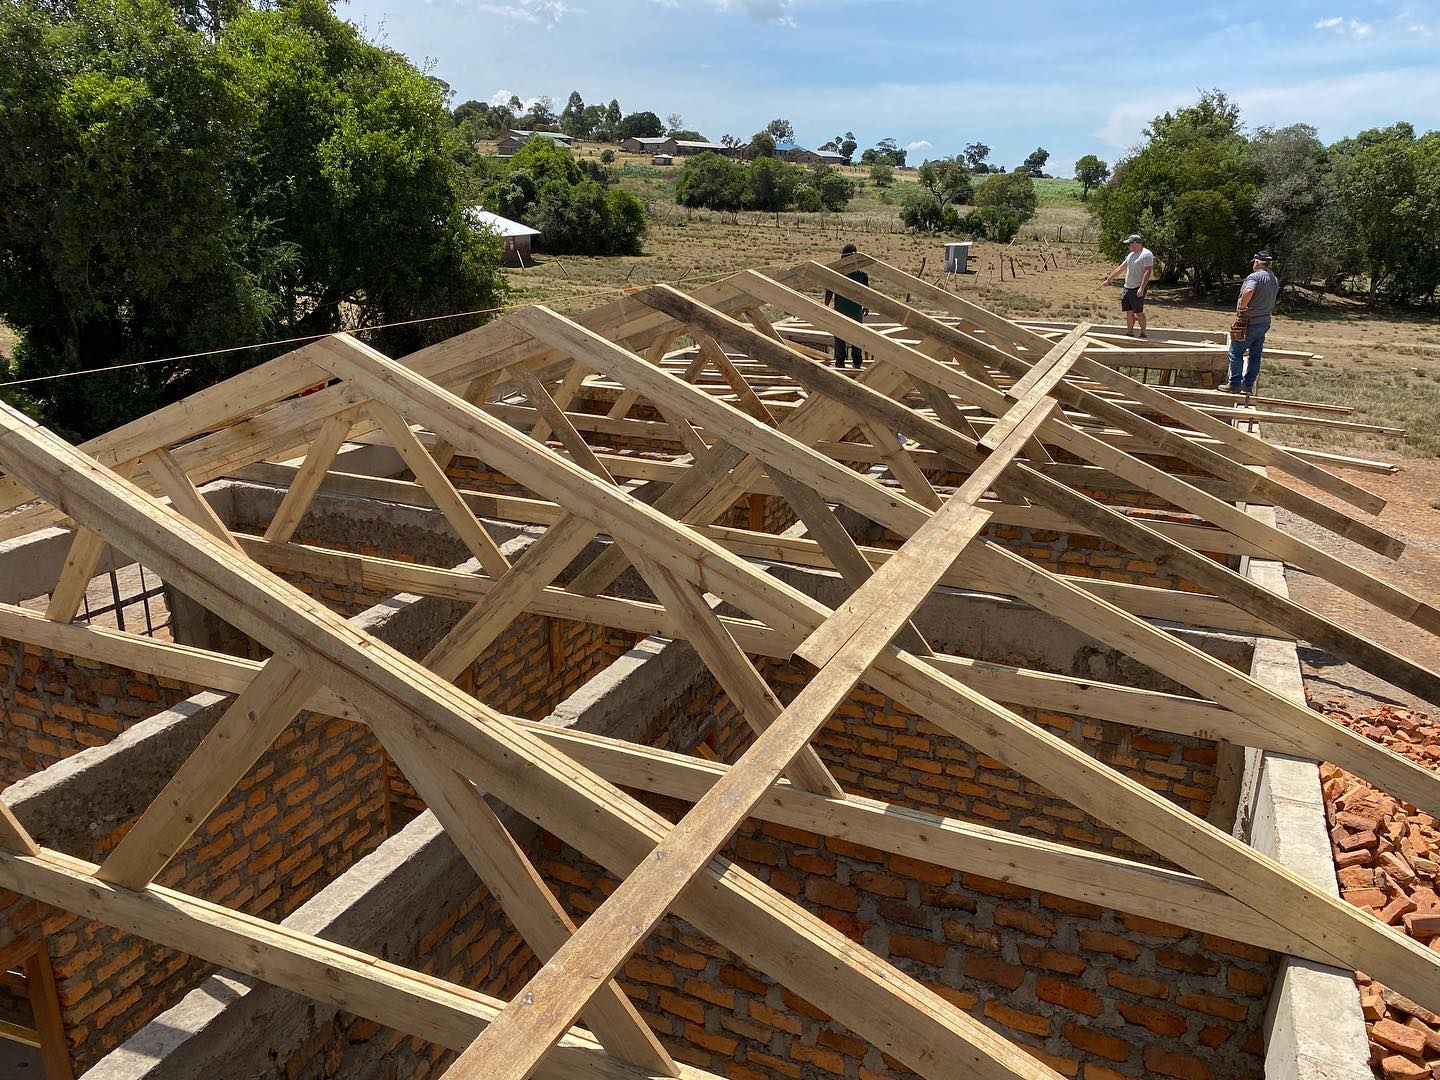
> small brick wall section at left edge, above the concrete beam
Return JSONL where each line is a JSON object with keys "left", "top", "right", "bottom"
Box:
{"left": 0, "top": 638, "right": 202, "bottom": 788}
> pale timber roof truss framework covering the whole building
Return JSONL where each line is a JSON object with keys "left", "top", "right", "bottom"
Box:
{"left": 0, "top": 255, "right": 1440, "bottom": 1080}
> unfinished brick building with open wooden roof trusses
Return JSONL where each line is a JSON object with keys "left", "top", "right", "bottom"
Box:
{"left": 0, "top": 256, "right": 1440, "bottom": 1080}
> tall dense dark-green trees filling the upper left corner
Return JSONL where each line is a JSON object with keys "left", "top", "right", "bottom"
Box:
{"left": 0, "top": 0, "right": 503, "bottom": 436}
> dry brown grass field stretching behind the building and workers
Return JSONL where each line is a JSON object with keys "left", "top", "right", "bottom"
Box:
{"left": 510, "top": 148, "right": 1440, "bottom": 463}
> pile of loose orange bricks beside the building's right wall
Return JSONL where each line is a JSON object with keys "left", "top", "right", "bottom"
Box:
{"left": 1320, "top": 698, "right": 1440, "bottom": 1080}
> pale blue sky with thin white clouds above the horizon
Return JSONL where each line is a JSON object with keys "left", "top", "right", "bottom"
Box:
{"left": 338, "top": 0, "right": 1440, "bottom": 174}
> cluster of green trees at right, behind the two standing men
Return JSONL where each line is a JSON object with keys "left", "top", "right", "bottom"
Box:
{"left": 1090, "top": 89, "right": 1440, "bottom": 302}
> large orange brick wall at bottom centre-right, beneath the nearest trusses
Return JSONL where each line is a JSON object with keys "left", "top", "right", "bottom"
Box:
{"left": 529, "top": 822, "right": 1276, "bottom": 1080}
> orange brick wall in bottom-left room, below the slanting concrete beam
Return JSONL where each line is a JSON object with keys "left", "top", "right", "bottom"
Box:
{"left": 0, "top": 703, "right": 384, "bottom": 1071}
